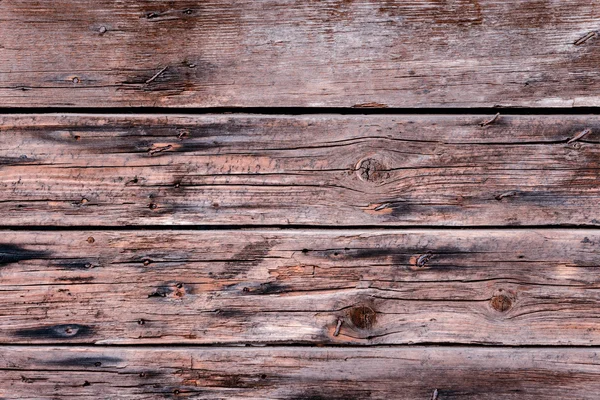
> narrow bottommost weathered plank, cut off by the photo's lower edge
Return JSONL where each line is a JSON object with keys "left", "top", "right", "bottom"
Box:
{"left": 0, "top": 347, "right": 600, "bottom": 400}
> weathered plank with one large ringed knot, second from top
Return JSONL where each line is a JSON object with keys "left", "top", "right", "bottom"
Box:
{"left": 0, "top": 114, "right": 600, "bottom": 226}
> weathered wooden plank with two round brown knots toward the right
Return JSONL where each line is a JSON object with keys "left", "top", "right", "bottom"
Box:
{"left": 0, "top": 230, "right": 600, "bottom": 345}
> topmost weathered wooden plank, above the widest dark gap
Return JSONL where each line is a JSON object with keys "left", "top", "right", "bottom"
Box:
{"left": 0, "top": 0, "right": 600, "bottom": 107}
